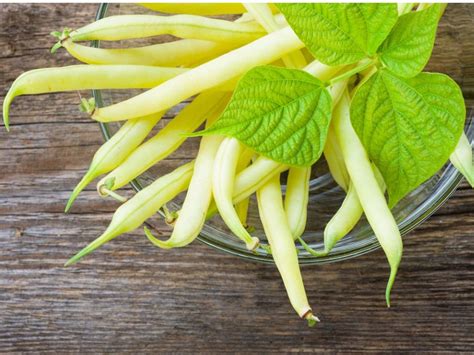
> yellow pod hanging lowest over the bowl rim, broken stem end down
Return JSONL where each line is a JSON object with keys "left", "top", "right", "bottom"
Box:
{"left": 257, "top": 174, "right": 319, "bottom": 322}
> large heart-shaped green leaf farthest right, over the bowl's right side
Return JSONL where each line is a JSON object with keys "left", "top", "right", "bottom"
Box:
{"left": 351, "top": 69, "right": 466, "bottom": 207}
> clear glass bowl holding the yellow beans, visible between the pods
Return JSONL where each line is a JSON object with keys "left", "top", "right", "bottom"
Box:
{"left": 93, "top": 4, "right": 474, "bottom": 264}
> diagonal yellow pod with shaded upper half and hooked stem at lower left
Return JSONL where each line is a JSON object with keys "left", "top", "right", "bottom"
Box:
{"left": 97, "top": 92, "right": 230, "bottom": 194}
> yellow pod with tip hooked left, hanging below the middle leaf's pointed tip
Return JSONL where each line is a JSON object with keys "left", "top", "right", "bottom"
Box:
{"left": 141, "top": 100, "right": 227, "bottom": 249}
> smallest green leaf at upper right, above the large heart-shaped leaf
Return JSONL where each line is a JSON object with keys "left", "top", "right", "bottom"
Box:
{"left": 379, "top": 4, "right": 441, "bottom": 78}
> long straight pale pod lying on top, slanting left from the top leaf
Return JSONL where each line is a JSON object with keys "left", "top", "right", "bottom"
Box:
{"left": 92, "top": 27, "right": 304, "bottom": 122}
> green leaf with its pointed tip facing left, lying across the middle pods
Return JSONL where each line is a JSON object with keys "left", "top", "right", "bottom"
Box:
{"left": 202, "top": 66, "right": 332, "bottom": 166}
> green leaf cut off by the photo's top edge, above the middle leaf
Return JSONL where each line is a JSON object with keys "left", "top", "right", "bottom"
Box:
{"left": 278, "top": 3, "right": 398, "bottom": 65}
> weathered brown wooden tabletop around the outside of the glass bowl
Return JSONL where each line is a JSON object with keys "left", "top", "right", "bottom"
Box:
{"left": 0, "top": 4, "right": 474, "bottom": 353}
